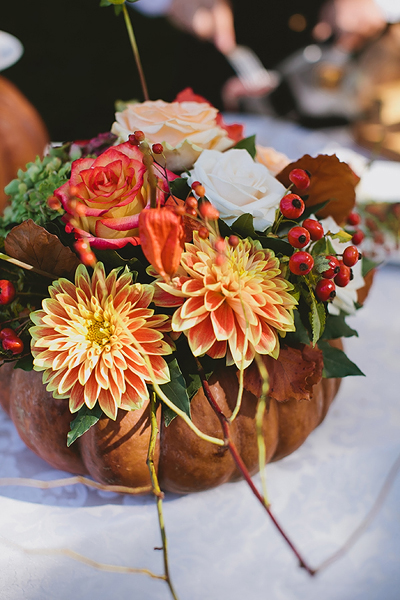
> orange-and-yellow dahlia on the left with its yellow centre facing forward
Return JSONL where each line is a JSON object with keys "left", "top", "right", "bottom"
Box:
{"left": 30, "top": 263, "right": 172, "bottom": 419}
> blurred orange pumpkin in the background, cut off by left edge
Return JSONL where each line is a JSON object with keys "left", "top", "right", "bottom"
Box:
{"left": 0, "top": 77, "right": 49, "bottom": 213}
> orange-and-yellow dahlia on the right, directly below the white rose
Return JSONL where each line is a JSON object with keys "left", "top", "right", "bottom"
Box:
{"left": 154, "top": 232, "right": 297, "bottom": 368}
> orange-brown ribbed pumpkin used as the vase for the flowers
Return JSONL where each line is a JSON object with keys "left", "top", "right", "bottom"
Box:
{"left": 0, "top": 343, "right": 340, "bottom": 493}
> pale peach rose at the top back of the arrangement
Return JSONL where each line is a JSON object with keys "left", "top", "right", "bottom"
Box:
{"left": 111, "top": 100, "right": 235, "bottom": 171}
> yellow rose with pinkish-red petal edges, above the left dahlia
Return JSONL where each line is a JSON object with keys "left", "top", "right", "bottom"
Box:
{"left": 54, "top": 142, "right": 175, "bottom": 249}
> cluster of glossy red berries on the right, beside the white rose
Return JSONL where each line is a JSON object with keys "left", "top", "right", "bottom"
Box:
{"left": 279, "top": 169, "right": 363, "bottom": 302}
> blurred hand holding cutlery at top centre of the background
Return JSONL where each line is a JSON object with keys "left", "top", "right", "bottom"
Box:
{"left": 168, "top": 0, "right": 236, "bottom": 54}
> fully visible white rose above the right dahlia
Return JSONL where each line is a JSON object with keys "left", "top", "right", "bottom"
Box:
{"left": 188, "top": 148, "right": 285, "bottom": 231}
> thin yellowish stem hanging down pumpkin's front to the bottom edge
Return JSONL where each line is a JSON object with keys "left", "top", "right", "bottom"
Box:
{"left": 147, "top": 394, "right": 178, "bottom": 600}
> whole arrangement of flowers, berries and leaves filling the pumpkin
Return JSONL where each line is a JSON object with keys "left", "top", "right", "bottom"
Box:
{"left": 0, "top": 0, "right": 373, "bottom": 594}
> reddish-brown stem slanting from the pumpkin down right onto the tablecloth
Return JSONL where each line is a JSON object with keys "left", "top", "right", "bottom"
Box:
{"left": 196, "top": 360, "right": 316, "bottom": 575}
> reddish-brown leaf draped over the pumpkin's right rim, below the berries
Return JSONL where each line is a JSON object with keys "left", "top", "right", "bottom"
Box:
{"left": 244, "top": 344, "right": 323, "bottom": 402}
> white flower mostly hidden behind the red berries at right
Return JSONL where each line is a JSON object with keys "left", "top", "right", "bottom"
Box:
{"left": 321, "top": 217, "right": 365, "bottom": 315}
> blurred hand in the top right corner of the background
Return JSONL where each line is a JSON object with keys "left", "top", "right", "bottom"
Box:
{"left": 313, "top": 0, "right": 386, "bottom": 51}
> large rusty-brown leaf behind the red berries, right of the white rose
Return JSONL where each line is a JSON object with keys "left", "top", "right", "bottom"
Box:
{"left": 276, "top": 154, "right": 360, "bottom": 225}
